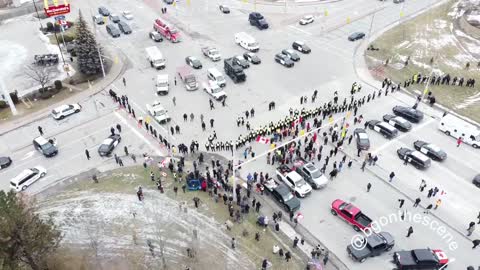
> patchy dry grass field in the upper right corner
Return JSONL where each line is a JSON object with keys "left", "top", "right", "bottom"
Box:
{"left": 365, "top": 0, "right": 480, "bottom": 122}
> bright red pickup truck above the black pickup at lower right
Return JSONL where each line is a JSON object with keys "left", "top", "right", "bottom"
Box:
{"left": 330, "top": 199, "right": 372, "bottom": 231}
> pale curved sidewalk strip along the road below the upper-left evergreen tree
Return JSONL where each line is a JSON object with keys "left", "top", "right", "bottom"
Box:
{"left": 0, "top": 47, "right": 125, "bottom": 136}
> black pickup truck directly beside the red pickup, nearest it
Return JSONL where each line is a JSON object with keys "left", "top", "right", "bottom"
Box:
{"left": 347, "top": 232, "right": 395, "bottom": 263}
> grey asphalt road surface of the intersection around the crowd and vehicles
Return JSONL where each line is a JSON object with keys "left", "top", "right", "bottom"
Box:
{"left": 0, "top": 0, "right": 480, "bottom": 269}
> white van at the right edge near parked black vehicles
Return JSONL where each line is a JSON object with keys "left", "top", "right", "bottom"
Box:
{"left": 438, "top": 114, "right": 480, "bottom": 148}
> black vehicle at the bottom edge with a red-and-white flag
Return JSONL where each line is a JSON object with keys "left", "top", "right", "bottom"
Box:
{"left": 393, "top": 248, "right": 448, "bottom": 269}
